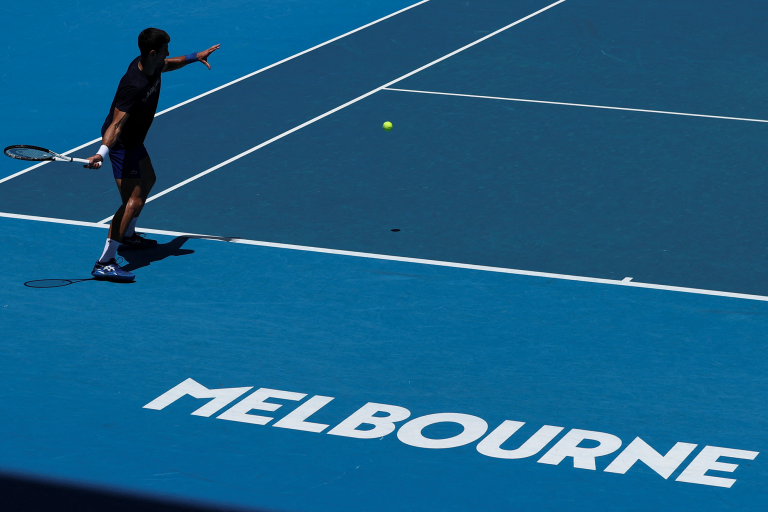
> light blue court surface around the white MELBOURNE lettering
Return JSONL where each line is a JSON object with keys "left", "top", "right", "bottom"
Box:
{"left": 0, "top": 219, "right": 768, "bottom": 511}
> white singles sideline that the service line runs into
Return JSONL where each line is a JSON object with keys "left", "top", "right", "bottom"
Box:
{"left": 99, "top": 0, "right": 565, "bottom": 224}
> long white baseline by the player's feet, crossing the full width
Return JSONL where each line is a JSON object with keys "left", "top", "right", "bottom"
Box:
{"left": 0, "top": 212, "right": 768, "bottom": 302}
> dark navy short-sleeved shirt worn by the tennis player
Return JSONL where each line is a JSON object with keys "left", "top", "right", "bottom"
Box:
{"left": 101, "top": 57, "right": 163, "bottom": 149}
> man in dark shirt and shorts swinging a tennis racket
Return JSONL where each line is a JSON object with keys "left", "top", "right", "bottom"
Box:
{"left": 86, "top": 28, "right": 220, "bottom": 281}
